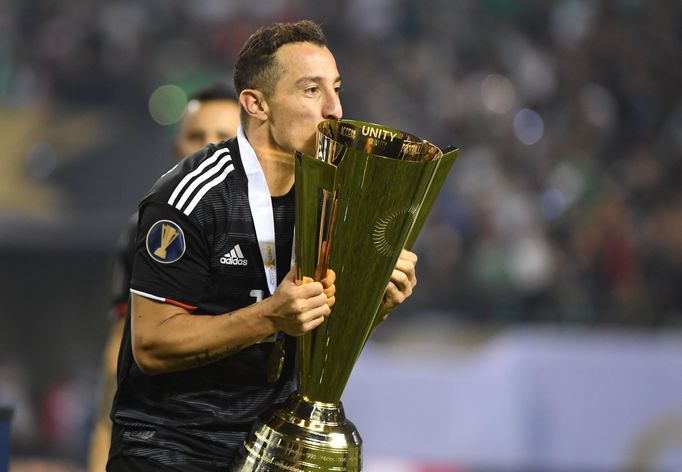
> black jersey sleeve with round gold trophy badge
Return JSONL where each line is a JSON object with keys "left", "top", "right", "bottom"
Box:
{"left": 130, "top": 202, "right": 210, "bottom": 311}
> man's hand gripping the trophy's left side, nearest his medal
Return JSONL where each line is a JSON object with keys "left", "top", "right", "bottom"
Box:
{"left": 270, "top": 268, "right": 336, "bottom": 336}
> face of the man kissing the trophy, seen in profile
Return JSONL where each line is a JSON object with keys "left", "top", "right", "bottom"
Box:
{"left": 267, "top": 42, "right": 343, "bottom": 155}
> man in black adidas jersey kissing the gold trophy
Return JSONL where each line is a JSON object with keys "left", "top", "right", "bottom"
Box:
{"left": 108, "top": 21, "right": 416, "bottom": 471}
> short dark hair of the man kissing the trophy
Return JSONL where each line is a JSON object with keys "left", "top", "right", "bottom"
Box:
{"left": 234, "top": 20, "right": 327, "bottom": 95}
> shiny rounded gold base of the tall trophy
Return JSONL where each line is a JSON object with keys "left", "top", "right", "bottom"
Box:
{"left": 234, "top": 392, "right": 362, "bottom": 472}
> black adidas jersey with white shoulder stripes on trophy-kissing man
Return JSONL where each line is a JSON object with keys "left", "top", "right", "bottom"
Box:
{"left": 110, "top": 138, "right": 295, "bottom": 471}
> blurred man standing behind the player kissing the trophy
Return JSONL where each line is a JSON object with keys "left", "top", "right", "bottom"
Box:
{"left": 88, "top": 83, "right": 240, "bottom": 472}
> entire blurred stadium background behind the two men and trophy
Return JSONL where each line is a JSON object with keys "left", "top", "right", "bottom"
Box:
{"left": 0, "top": 0, "right": 682, "bottom": 472}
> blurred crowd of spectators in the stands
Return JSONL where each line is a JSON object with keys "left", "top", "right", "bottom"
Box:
{"left": 0, "top": 0, "right": 682, "bottom": 464}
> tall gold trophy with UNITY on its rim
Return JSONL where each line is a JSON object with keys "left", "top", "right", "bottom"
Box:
{"left": 235, "top": 120, "right": 458, "bottom": 472}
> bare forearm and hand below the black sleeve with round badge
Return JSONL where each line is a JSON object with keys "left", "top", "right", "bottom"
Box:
{"left": 131, "top": 270, "right": 336, "bottom": 375}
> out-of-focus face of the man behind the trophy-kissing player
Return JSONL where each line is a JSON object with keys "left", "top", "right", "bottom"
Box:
{"left": 175, "top": 100, "right": 239, "bottom": 159}
